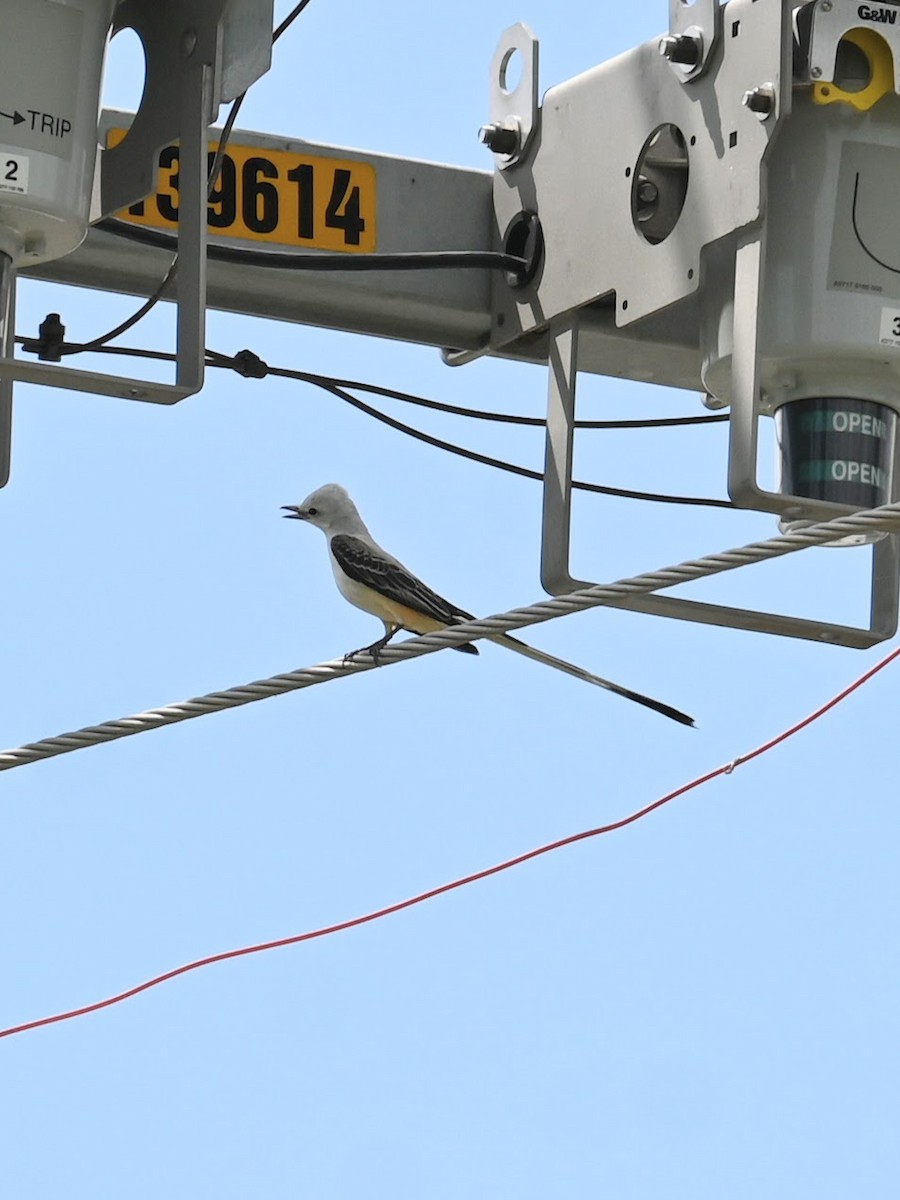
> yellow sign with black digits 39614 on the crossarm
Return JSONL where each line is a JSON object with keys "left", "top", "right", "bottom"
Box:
{"left": 108, "top": 130, "right": 376, "bottom": 253}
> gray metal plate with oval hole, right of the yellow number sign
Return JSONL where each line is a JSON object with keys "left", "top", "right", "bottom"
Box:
{"left": 491, "top": 0, "right": 791, "bottom": 348}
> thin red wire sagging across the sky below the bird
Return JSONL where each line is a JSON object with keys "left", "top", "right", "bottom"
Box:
{"left": 0, "top": 647, "right": 900, "bottom": 1038}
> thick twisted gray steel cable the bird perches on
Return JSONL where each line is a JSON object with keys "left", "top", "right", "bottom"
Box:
{"left": 0, "top": 504, "right": 900, "bottom": 770}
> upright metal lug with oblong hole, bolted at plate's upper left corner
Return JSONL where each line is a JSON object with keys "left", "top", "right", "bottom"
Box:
{"left": 481, "top": 22, "right": 539, "bottom": 170}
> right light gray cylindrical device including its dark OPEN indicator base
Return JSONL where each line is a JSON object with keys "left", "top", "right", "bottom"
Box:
{"left": 701, "top": 83, "right": 900, "bottom": 535}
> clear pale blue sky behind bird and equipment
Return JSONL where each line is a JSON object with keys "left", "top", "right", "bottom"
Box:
{"left": 0, "top": 0, "right": 900, "bottom": 1200}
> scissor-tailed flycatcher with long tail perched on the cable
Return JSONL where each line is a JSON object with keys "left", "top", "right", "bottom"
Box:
{"left": 283, "top": 484, "right": 694, "bottom": 725}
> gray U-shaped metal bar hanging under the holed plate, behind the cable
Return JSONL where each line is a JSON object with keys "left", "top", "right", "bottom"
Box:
{"left": 541, "top": 312, "right": 900, "bottom": 649}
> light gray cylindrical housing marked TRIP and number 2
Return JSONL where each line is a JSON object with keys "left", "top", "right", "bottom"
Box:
{"left": 0, "top": 0, "right": 115, "bottom": 265}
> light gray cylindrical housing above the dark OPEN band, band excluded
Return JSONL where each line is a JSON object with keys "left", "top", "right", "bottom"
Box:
{"left": 701, "top": 92, "right": 900, "bottom": 414}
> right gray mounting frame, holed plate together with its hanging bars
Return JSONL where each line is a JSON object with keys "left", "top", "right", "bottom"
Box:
{"left": 491, "top": 0, "right": 900, "bottom": 648}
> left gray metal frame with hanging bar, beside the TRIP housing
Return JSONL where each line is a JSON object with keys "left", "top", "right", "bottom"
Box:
{"left": 0, "top": 0, "right": 274, "bottom": 487}
